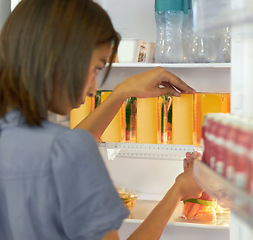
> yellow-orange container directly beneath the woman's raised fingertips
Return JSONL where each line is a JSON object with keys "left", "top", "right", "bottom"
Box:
{"left": 172, "top": 94, "right": 193, "bottom": 145}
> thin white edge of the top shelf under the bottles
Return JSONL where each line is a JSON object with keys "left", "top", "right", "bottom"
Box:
{"left": 109, "top": 63, "right": 231, "bottom": 68}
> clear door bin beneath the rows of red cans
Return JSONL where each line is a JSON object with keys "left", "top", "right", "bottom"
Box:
{"left": 194, "top": 160, "right": 253, "bottom": 227}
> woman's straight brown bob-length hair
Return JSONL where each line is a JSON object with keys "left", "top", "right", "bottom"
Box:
{"left": 0, "top": 0, "right": 120, "bottom": 125}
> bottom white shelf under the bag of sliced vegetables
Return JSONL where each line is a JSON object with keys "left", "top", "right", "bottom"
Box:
{"left": 119, "top": 200, "right": 230, "bottom": 240}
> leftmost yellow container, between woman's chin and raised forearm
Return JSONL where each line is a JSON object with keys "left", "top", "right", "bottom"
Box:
{"left": 70, "top": 97, "right": 95, "bottom": 129}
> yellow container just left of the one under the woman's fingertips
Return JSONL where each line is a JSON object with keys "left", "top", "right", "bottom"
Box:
{"left": 136, "top": 98, "right": 161, "bottom": 144}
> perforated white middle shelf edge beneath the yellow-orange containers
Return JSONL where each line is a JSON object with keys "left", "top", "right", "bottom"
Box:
{"left": 99, "top": 142, "right": 200, "bottom": 161}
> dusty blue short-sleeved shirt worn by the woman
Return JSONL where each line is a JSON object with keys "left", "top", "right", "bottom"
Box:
{"left": 0, "top": 110, "right": 129, "bottom": 240}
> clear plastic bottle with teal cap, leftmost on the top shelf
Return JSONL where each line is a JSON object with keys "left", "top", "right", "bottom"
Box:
{"left": 155, "top": 0, "right": 184, "bottom": 63}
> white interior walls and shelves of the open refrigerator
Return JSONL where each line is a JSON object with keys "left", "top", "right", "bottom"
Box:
{"left": 94, "top": 0, "right": 231, "bottom": 239}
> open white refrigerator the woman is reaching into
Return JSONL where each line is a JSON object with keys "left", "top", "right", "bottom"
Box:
{"left": 0, "top": 0, "right": 253, "bottom": 240}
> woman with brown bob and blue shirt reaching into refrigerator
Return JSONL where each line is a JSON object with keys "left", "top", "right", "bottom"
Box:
{"left": 0, "top": 0, "right": 201, "bottom": 240}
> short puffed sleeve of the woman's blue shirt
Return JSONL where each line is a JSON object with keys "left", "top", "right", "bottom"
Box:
{"left": 51, "top": 130, "right": 129, "bottom": 240}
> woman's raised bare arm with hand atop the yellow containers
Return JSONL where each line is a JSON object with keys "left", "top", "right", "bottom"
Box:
{"left": 76, "top": 67, "right": 195, "bottom": 140}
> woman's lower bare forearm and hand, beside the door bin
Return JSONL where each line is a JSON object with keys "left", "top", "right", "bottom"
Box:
{"left": 103, "top": 158, "right": 202, "bottom": 240}
